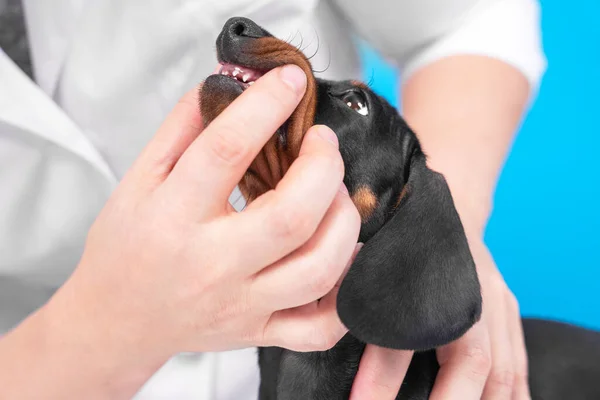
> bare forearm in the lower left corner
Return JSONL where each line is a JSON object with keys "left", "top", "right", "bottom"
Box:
{"left": 0, "top": 282, "right": 160, "bottom": 399}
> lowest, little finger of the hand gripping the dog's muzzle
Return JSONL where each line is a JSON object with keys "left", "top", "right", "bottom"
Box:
{"left": 261, "top": 243, "right": 362, "bottom": 351}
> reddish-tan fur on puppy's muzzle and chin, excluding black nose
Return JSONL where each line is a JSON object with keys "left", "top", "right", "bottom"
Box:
{"left": 200, "top": 37, "right": 317, "bottom": 201}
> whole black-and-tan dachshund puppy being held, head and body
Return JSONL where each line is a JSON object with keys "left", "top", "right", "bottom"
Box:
{"left": 200, "top": 18, "right": 600, "bottom": 400}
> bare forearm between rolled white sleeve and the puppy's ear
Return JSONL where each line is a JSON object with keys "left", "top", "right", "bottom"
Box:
{"left": 402, "top": 55, "right": 530, "bottom": 233}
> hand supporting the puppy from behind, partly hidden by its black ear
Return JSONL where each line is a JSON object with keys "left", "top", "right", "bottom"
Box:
{"left": 350, "top": 225, "right": 530, "bottom": 400}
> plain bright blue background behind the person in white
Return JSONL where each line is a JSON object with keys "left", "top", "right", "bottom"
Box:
{"left": 361, "top": 0, "right": 600, "bottom": 329}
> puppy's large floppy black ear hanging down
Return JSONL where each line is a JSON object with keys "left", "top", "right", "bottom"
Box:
{"left": 337, "top": 149, "right": 481, "bottom": 350}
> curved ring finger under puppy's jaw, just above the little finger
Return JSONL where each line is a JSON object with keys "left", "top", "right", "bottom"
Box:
{"left": 252, "top": 192, "right": 360, "bottom": 311}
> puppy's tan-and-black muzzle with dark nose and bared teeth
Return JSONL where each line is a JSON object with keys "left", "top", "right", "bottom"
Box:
{"left": 200, "top": 18, "right": 317, "bottom": 201}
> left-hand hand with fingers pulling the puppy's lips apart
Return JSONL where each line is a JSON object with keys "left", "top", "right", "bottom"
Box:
{"left": 48, "top": 66, "right": 360, "bottom": 390}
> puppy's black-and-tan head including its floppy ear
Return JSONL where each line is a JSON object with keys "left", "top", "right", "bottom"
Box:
{"left": 200, "top": 18, "right": 481, "bottom": 350}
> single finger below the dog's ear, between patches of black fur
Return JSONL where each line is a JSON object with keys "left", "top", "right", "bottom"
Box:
{"left": 350, "top": 345, "right": 413, "bottom": 400}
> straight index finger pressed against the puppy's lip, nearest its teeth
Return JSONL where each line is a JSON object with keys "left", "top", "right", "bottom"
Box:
{"left": 167, "top": 65, "right": 306, "bottom": 214}
